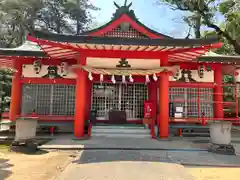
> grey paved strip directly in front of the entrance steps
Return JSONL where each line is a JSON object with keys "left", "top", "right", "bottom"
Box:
{"left": 39, "top": 136, "right": 206, "bottom": 151}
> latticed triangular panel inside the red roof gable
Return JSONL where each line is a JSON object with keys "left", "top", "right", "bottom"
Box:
{"left": 103, "top": 25, "right": 148, "bottom": 39}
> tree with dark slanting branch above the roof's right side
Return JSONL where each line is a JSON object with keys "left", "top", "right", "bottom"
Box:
{"left": 160, "top": 0, "right": 240, "bottom": 54}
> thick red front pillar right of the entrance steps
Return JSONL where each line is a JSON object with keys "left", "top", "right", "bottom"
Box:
{"left": 159, "top": 72, "right": 169, "bottom": 138}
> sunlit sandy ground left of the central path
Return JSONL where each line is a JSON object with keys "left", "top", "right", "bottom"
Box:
{"left": 0, "top": 150, "right": 73, "bottom": 180}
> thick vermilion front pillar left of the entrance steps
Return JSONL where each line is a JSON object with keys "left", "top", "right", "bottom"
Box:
{"left": 74, "top": 57, "right": 87, "bottom": 138}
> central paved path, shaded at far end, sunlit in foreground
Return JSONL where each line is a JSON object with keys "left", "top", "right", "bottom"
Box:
{"left": 56, "top": 150, "right": 194, "bottom": 180}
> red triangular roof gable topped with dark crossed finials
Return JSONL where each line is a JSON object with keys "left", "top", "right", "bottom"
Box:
{"left": 82, "top": 0, "right": 171, "bottom": 39}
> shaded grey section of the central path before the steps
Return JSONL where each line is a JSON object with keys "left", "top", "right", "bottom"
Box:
{"left": 74, "top": 150, "right": 171, "bottom": 164}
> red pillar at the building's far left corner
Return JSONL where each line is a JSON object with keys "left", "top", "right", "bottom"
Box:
{"left": 9, "top": 62, "right": 22, "bottom": 121}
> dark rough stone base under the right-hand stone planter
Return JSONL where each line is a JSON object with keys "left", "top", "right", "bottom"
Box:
{"left": 208, "top": 143, "right": 236, "bottom": 155}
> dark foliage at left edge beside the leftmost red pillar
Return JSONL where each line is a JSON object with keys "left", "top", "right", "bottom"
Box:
{"left": 0, "top": 69, "right": 13, "bottom": 120}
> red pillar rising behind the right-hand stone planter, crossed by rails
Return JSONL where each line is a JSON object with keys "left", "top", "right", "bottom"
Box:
{"left": 214, "top": 65, "right": 224, "bottom": 118}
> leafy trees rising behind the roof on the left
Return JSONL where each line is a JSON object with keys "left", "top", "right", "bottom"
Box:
{"left": 0, "top": 0, "right": 97, "bottom": 48}
